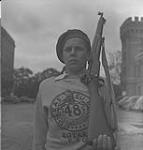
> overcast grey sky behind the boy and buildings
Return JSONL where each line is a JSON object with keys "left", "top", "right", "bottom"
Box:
{"left": 1, "top": 0, "right": 143, "bottom": 72}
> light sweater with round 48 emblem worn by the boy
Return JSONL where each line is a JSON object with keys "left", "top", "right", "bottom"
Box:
{"left": 33, "top": 75, "right": 118, "bottom": 150}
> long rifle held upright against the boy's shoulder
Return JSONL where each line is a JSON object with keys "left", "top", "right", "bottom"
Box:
{"left": 80, "top": 12, "right": 115, "bottom": 148}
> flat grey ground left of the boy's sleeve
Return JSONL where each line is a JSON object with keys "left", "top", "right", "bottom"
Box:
{"left": 1, "top": 104, "right": 34, "bottom": 150}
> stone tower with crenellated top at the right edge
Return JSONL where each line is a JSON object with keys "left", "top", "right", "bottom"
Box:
{"left": 120, "top": 17, "right": 143, "bottom": 96}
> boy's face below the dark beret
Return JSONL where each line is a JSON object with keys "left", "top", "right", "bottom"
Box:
{"left": 63, "top": 38, "right": 89, "bottom": 72}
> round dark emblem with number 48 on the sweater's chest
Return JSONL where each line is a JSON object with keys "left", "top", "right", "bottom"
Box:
{"left": 50, "top": 90, "right": 89, "bottom": 132}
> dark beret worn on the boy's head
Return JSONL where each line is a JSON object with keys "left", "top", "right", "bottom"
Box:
{"left": 56, "top": 29, "right": 91, "bottom": 63}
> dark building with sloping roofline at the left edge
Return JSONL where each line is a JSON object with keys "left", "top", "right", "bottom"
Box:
{"left": 1, "top": 27, "right": 15, "bottom": 96}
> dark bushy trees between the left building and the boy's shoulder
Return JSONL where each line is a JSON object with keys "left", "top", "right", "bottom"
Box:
{"left": 13, "top": 67, "right": 60, "bottom": 98}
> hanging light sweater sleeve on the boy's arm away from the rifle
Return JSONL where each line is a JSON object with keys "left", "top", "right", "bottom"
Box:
{"left": 32, "top": 93, "right": 48, "bottom": 150}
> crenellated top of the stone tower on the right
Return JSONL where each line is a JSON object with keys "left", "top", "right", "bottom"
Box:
{"left": 120, "top": 17, "right": 143, "bottom": 39}
